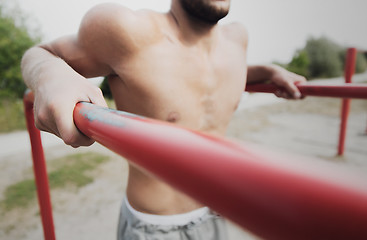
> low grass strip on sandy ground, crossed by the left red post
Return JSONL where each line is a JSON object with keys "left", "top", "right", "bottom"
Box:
{"left": 0, "top": 153, "right": 109, "bottom": 211}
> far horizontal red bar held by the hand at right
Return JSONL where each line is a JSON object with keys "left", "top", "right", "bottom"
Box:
{"left": 246, "top": 83, "right": 367, "bottom": 99}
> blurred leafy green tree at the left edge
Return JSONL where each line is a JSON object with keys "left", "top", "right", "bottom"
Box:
{"left": 0, "top": 4, "right": 39, "bottom": 97}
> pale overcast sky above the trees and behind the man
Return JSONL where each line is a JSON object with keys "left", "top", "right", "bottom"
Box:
{"left": 5, "top": 0, "right": 367, "bottom": 64}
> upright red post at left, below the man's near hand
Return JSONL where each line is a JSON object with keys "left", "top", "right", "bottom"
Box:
{"left": 23, "top": 91, "right": 56, "bottom": 240}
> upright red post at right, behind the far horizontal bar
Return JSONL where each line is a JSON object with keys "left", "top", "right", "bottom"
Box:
{"left": 338, "top": 48, "right": 357, "bottom": 156}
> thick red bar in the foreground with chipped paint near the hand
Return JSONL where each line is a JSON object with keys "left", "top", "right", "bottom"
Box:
{"left": 74, "top": 103, "right": 367, "bottom": 239}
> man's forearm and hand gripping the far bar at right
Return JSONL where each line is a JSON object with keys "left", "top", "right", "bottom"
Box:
{"left": 247, "top": 65, "right": 307, "bottom": 99}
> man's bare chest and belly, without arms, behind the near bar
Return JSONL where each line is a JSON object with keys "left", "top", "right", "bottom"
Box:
{"left": 105, "top": 7, "right": 246, "bottom": 214}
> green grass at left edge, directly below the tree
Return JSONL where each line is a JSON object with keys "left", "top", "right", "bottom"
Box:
{"left": 0, "top": 98, "right": 26, "bottom": 133}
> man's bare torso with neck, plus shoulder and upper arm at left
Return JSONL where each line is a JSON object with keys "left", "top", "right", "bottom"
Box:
{"left": 38, "top": 1, "right": 247, "bottom": 214}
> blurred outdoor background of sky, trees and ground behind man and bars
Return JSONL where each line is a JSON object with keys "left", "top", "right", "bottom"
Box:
{"left": 0, "top": 0, "right": 367, "bottom": 239}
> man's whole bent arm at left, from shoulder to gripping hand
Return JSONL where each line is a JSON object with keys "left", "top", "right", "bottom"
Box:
{"left": 21, "top": 4, "right": 142, "bottom": 147}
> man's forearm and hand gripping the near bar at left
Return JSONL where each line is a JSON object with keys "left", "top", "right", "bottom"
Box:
{"left": 22, "top": 42, "right": 106, "bottom": 147}
